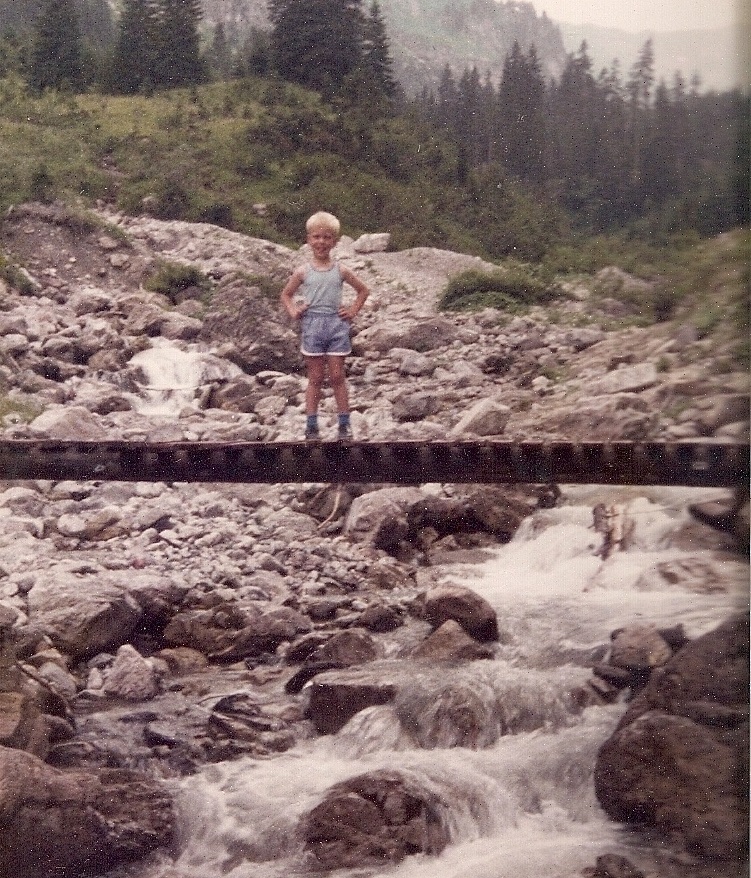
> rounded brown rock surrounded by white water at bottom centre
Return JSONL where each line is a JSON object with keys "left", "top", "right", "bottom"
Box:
{"left": 303, "top": 770, "right": 449, "bottom": 870}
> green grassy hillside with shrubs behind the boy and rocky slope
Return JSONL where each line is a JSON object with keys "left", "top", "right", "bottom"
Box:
{"left": 0, "top": 79, "right": 566, "bottom": 259}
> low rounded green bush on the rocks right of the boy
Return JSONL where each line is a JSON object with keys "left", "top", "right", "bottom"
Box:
{"left": 438, "top": 264, "right": 563, "bottom": 313}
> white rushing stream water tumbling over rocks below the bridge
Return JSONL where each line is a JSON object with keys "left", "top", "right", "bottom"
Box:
{"left": 117, "top": 488, "right": 747, "bottom": 878}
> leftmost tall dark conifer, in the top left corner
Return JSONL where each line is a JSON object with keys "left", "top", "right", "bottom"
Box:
{"left": 27, "top": 0, "right": 83, "bottom": 92}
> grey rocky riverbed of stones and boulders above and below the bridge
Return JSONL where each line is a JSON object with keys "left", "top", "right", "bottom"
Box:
{"left": 0, "top": 205, "right": 749, "bottom": 878}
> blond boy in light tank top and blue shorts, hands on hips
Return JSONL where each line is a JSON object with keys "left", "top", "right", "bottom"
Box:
{"left": 280, "top": 211, "right": 369, "bottom": 441}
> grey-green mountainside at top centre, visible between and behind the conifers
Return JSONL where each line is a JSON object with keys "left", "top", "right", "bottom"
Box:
{"left": 202, "top": 0, "right": 566, "bottom": 94}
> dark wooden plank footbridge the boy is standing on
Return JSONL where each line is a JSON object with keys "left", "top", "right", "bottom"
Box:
{"left": 0, "top": 439, "right": 749, "bottom": 488}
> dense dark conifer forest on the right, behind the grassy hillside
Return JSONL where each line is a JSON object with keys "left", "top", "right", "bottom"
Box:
{"left": 413, "top": 41, "right": 749, "bottom": 239}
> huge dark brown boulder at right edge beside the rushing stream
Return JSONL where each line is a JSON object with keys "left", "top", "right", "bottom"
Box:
{"left": 595, "top": 617, "right": 748, "bottom": 860}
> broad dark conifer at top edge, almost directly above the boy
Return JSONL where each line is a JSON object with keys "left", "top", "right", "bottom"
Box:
{"left": 269, "top": 0, "right": 364, "bottom": 91}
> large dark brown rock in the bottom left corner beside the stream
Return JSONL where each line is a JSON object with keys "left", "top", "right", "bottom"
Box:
{"left": 0, "top": 747, "right": 175, "bottom": 878}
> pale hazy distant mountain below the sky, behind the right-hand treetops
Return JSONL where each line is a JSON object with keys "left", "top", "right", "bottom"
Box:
{"left": 558, "top": 22, "right": 741, "bottom": 91}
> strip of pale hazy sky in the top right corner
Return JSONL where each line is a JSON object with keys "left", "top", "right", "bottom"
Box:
{"left": 532, "top": 0, "right": 746, "bottom": 31}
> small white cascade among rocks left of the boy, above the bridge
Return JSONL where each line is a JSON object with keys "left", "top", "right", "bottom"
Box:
{"left": 129, "top": 338, "right": 242, "bottom": 416}
